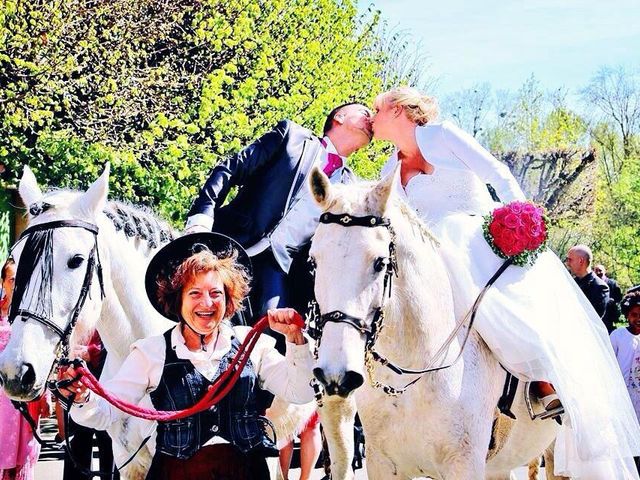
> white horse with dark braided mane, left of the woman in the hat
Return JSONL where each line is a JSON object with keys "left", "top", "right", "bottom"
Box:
{"left": 0, "top": 167, "right": 172, "bottom": 479}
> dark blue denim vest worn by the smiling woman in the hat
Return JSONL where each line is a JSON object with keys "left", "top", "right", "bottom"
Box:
{"left": 150, "top": 329, "right": 277, "bottom": 459}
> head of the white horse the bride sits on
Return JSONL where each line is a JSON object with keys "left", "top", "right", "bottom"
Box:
{"left": 310, "top": 165, "right": 395, "bottom": 397}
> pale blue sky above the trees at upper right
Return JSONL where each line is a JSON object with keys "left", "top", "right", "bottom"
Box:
{"left": 368, "top": 0, "right": 640, "bottom": 94}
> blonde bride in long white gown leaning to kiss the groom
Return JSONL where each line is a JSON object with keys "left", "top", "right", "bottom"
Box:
{"left": 373, "top": 87, "right": 640, "bottom": 479}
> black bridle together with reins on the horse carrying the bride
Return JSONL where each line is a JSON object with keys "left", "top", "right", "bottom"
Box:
{"left": 309, "top": 212, "right": 512, "bottom": 402}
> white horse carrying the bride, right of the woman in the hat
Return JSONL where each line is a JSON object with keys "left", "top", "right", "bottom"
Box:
{"left": 310, "top": 169, "right": 557, "bottom": 480}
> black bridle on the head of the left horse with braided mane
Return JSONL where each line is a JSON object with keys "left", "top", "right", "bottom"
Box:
{"left": 9, "top": 220, "right": 105, "bottom": 358}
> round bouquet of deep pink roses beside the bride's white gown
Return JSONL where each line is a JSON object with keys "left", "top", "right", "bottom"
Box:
{"left": 483, "top": 201, "right": 548, "bottom": 266}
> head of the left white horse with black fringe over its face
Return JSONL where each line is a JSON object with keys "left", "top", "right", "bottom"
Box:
{"left": 0, "top": 166, "right": 109, "bottom": 400}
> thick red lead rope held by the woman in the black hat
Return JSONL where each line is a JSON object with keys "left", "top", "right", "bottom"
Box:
{"left": 75, "top": 314, "right": 304, "bottom": 422}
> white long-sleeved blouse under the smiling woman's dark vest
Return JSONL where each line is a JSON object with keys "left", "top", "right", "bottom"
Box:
{"left": 71, "top": 323, "right": 314, "bottom": 430}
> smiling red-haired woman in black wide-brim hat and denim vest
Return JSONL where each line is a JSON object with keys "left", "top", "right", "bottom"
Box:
{"left": 60, "top": 233, "right": 313, "bottom": 480}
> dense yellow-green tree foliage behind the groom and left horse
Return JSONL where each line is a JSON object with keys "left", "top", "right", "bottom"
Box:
{"left": 0, "top": 0, "right": 381, "bottom": 222}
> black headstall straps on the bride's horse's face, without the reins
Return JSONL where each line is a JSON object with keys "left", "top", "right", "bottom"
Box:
{"left": 313, "top": 212, "right": 398, "bottom": 351}
